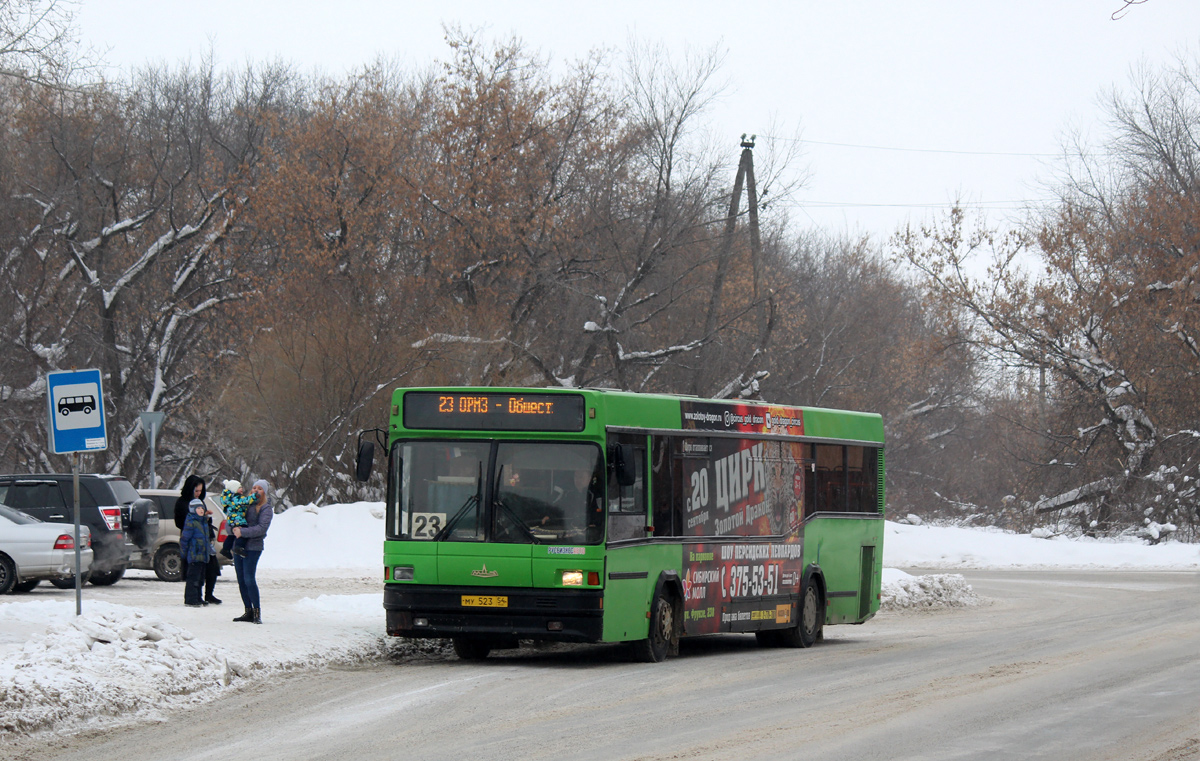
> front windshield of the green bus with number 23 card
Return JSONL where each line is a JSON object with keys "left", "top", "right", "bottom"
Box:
{"left": 388, "top": 441, "right": 605, "bottom": 544}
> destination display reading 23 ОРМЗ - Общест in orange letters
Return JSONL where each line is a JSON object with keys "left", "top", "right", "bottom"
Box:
{"left": 404, "top": 391, "right": 584, "bottom": 432}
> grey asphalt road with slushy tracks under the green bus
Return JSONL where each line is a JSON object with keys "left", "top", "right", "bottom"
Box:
{"left": 17, "top": 571, "right": 1200, "bottom": 761}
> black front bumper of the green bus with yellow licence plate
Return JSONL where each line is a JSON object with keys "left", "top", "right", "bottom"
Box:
{"left": 383, "top": 583, "right": 604, "bottom": 642}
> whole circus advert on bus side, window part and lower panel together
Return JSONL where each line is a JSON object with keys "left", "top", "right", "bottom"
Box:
{"left": 672, "top": 437, "right": 805, "bottom": 634}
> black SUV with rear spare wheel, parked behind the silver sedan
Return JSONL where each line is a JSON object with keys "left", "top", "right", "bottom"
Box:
{"left": 0, "top": 473, "right": 158, "bottom": 586}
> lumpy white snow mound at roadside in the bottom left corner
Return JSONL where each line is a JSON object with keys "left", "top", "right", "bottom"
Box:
{"left": 0, "top": 603, "right": 248, "bottom": 732}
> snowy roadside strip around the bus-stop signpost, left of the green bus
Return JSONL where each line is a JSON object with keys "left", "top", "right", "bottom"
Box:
{"left": 0, "top": 593, "right": 402, "bottom": 737}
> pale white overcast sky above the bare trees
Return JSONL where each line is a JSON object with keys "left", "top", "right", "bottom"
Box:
{"left": 79, "top": 0, "right": 1200, "bottom": 238}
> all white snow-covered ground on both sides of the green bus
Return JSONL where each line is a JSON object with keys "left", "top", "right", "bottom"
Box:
{"left": 0, "top": 503, "right": 1200, "bottom": 739}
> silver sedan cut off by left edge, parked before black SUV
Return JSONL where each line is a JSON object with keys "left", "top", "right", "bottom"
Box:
{"left": 0, "top": 504, "right": 92, "bottom": 594}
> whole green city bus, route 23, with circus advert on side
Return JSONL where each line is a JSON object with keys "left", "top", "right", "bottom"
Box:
{"left": 356, "top": 388, "right": 884, "bottom": 661}
